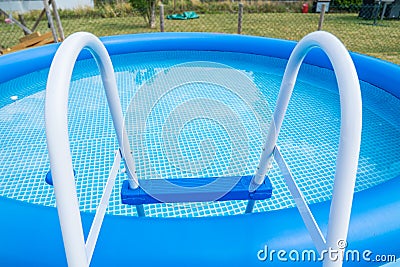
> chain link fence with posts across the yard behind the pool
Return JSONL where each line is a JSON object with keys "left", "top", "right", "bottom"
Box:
{"left": 0, "top": 0, "right": 400, "bottom": 64}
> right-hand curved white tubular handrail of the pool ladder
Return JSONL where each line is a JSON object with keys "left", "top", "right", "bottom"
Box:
{"left": 246, "top": 31, "right": 362, "bottom": 267}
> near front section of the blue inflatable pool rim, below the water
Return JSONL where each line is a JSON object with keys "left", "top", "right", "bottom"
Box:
{"left": 0, "top": 173, "right": 400, "bottom": 267}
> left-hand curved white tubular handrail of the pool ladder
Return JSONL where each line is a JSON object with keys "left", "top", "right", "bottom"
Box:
{"left": 45, "top": 32, "right": 138, "bottom": 267}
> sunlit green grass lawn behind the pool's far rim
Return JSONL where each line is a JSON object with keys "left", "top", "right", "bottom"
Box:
{"left": 0, "top": 13, "right": 400, "bottom": 64}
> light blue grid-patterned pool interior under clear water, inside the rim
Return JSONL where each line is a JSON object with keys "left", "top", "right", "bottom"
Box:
{"left": 0, "top": 52, "right": 400, "bottom": 217}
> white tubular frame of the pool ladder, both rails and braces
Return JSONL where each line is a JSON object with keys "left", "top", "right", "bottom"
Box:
{"left": 45, "top": 32, "right": 361, "bottom": 267}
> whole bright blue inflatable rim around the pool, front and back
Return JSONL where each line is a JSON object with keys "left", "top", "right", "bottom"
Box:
{"left": 0, "top": 33, "right": 400, "bottom": 266}
